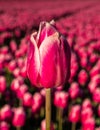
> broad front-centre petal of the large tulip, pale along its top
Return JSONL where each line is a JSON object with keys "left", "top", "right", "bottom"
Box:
{"left": 39, "top": 33, "right": 59, "bottom": 88}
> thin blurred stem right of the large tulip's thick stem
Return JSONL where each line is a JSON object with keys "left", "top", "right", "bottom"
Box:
{"left": 58, "top": 108, "right": 63, "bottom": 130}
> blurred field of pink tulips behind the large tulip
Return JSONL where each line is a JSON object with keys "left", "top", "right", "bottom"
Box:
{"left": 0, "top": 0, "right": 100, "bottom": 130}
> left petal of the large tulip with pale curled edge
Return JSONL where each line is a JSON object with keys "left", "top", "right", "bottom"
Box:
{"left": 27, "top": 34, "right": 40, "bottom": 85}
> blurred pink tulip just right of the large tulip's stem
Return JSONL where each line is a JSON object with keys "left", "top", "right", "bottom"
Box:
{"left": 54, "top": 91, "right": 68, "bottom": 108}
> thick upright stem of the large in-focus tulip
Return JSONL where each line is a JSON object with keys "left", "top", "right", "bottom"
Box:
{"left": 45, "top": 88, "right": 51, "bottom": 130}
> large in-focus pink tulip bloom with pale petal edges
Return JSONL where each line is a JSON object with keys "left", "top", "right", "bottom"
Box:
{"left": 27, "top": 22, "right": 71, "bottom": 88}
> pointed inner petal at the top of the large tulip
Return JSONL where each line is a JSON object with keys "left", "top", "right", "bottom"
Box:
{"left": 37, "top": 21, "right": 56, "bottom": 47}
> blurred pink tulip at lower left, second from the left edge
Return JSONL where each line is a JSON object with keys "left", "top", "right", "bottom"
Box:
{"left": 12, "top": 107, "right": 26, "bottom": 127}
